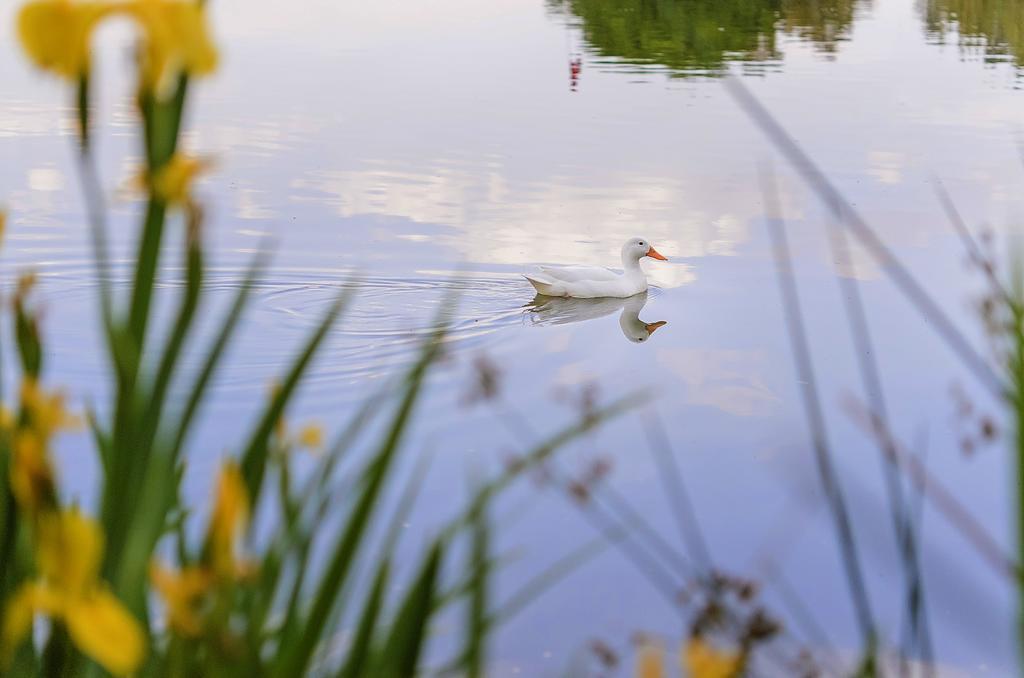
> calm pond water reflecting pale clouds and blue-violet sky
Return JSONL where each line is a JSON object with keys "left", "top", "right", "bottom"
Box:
{"left": 0, "top": 0, "right": 1024, "bottom": 676}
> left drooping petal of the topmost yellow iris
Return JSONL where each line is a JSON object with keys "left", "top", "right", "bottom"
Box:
{"left": 17, "top": 0, "right": 115, "bottom": 79}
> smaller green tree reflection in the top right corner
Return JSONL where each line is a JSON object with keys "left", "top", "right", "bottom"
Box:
{"left": 922, "top": 0, "right": 1024, "bottom": 63}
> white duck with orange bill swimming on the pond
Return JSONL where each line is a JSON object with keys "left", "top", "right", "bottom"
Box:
{"left": 523, "top": 238, "right": 669, "bottom": 299}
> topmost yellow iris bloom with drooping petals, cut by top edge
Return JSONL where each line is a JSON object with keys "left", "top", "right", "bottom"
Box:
{"left": 17, "top": 0, "right": 217, "bottom": 96}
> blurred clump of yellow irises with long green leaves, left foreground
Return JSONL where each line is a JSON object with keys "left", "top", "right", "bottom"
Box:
{"left": 0, "top": 0, "right": 629, "bottom": 677}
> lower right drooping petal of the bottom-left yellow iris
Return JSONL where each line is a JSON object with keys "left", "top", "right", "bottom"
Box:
{"left": 63, "top": 589, "right": 145, "bottom": 675}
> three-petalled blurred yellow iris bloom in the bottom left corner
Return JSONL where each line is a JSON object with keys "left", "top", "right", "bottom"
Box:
{"left": 0, "top": 510, "right": 146, "bottom": 675}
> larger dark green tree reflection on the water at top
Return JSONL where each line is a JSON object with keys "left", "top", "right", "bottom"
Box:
{"left": 548, "top": 0, "right": 867, "bottom": 76}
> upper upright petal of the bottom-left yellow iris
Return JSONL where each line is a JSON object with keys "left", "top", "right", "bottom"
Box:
{"left": 36, "top": 509, "right": 103, "bottom": 597}
